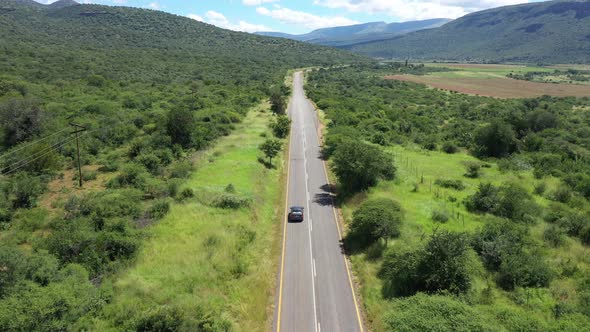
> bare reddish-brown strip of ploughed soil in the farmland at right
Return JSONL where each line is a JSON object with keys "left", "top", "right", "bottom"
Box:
{"left": 385, "top": 74, "right": 590, "bottom": 98}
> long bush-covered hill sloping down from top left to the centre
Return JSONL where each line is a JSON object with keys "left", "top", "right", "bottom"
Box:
{"left": 0, "top": 0, "right": 368, "bottom": 85}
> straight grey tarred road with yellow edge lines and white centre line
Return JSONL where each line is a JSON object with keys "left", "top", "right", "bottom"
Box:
{"left": 275, "top": 72, "right": 363, "bottom": 332}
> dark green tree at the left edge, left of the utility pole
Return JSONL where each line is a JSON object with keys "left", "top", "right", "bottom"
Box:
{"left": 0, "top": 99, "right": 44, "bottom": 147}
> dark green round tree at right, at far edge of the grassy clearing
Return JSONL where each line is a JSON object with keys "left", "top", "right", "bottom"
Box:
{"left": 475, "top": 121, "right": 516, "bottom": 157}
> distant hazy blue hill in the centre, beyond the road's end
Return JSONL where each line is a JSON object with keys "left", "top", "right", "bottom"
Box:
{"left": 256, "top": 18, "right": 451, "bottom": 47}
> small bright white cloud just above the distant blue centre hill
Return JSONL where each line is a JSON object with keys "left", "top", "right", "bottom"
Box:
{"left": 256, "top": 7, "right": 359, "bottom": 29}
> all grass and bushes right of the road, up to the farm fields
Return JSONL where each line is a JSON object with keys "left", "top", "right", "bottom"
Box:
{"left": 307, "top": 64, "right": 590, "bottom": 331}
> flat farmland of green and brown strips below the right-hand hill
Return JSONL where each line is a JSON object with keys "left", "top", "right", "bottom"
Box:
{"left": 386, "top": 64, "right": 590, "bottom": 98}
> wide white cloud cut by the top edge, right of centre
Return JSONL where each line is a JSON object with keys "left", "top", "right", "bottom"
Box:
{"left": 314, "top": 0, "right": 528, "bottom": 20}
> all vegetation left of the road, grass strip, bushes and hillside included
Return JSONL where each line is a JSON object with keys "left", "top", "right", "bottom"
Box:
{"left": 0, "top": 1, "right": 344, "bottom": 331}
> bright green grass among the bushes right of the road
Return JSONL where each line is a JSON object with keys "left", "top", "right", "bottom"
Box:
{"left": 342, "top": 146, "right": 590, "bottom": 331}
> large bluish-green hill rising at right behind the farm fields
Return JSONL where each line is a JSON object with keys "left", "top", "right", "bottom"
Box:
{"left": 344, "top": 0, "right": 590, "bottom": 63}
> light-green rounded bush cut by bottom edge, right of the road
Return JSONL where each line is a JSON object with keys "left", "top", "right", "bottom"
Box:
{"left": 383, "top": 294, "right": 499, "bottom": 332}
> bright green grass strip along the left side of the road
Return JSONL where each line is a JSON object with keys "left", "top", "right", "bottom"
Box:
{"left": 94, "top": 105, "right": 283, "bottom": 331}
